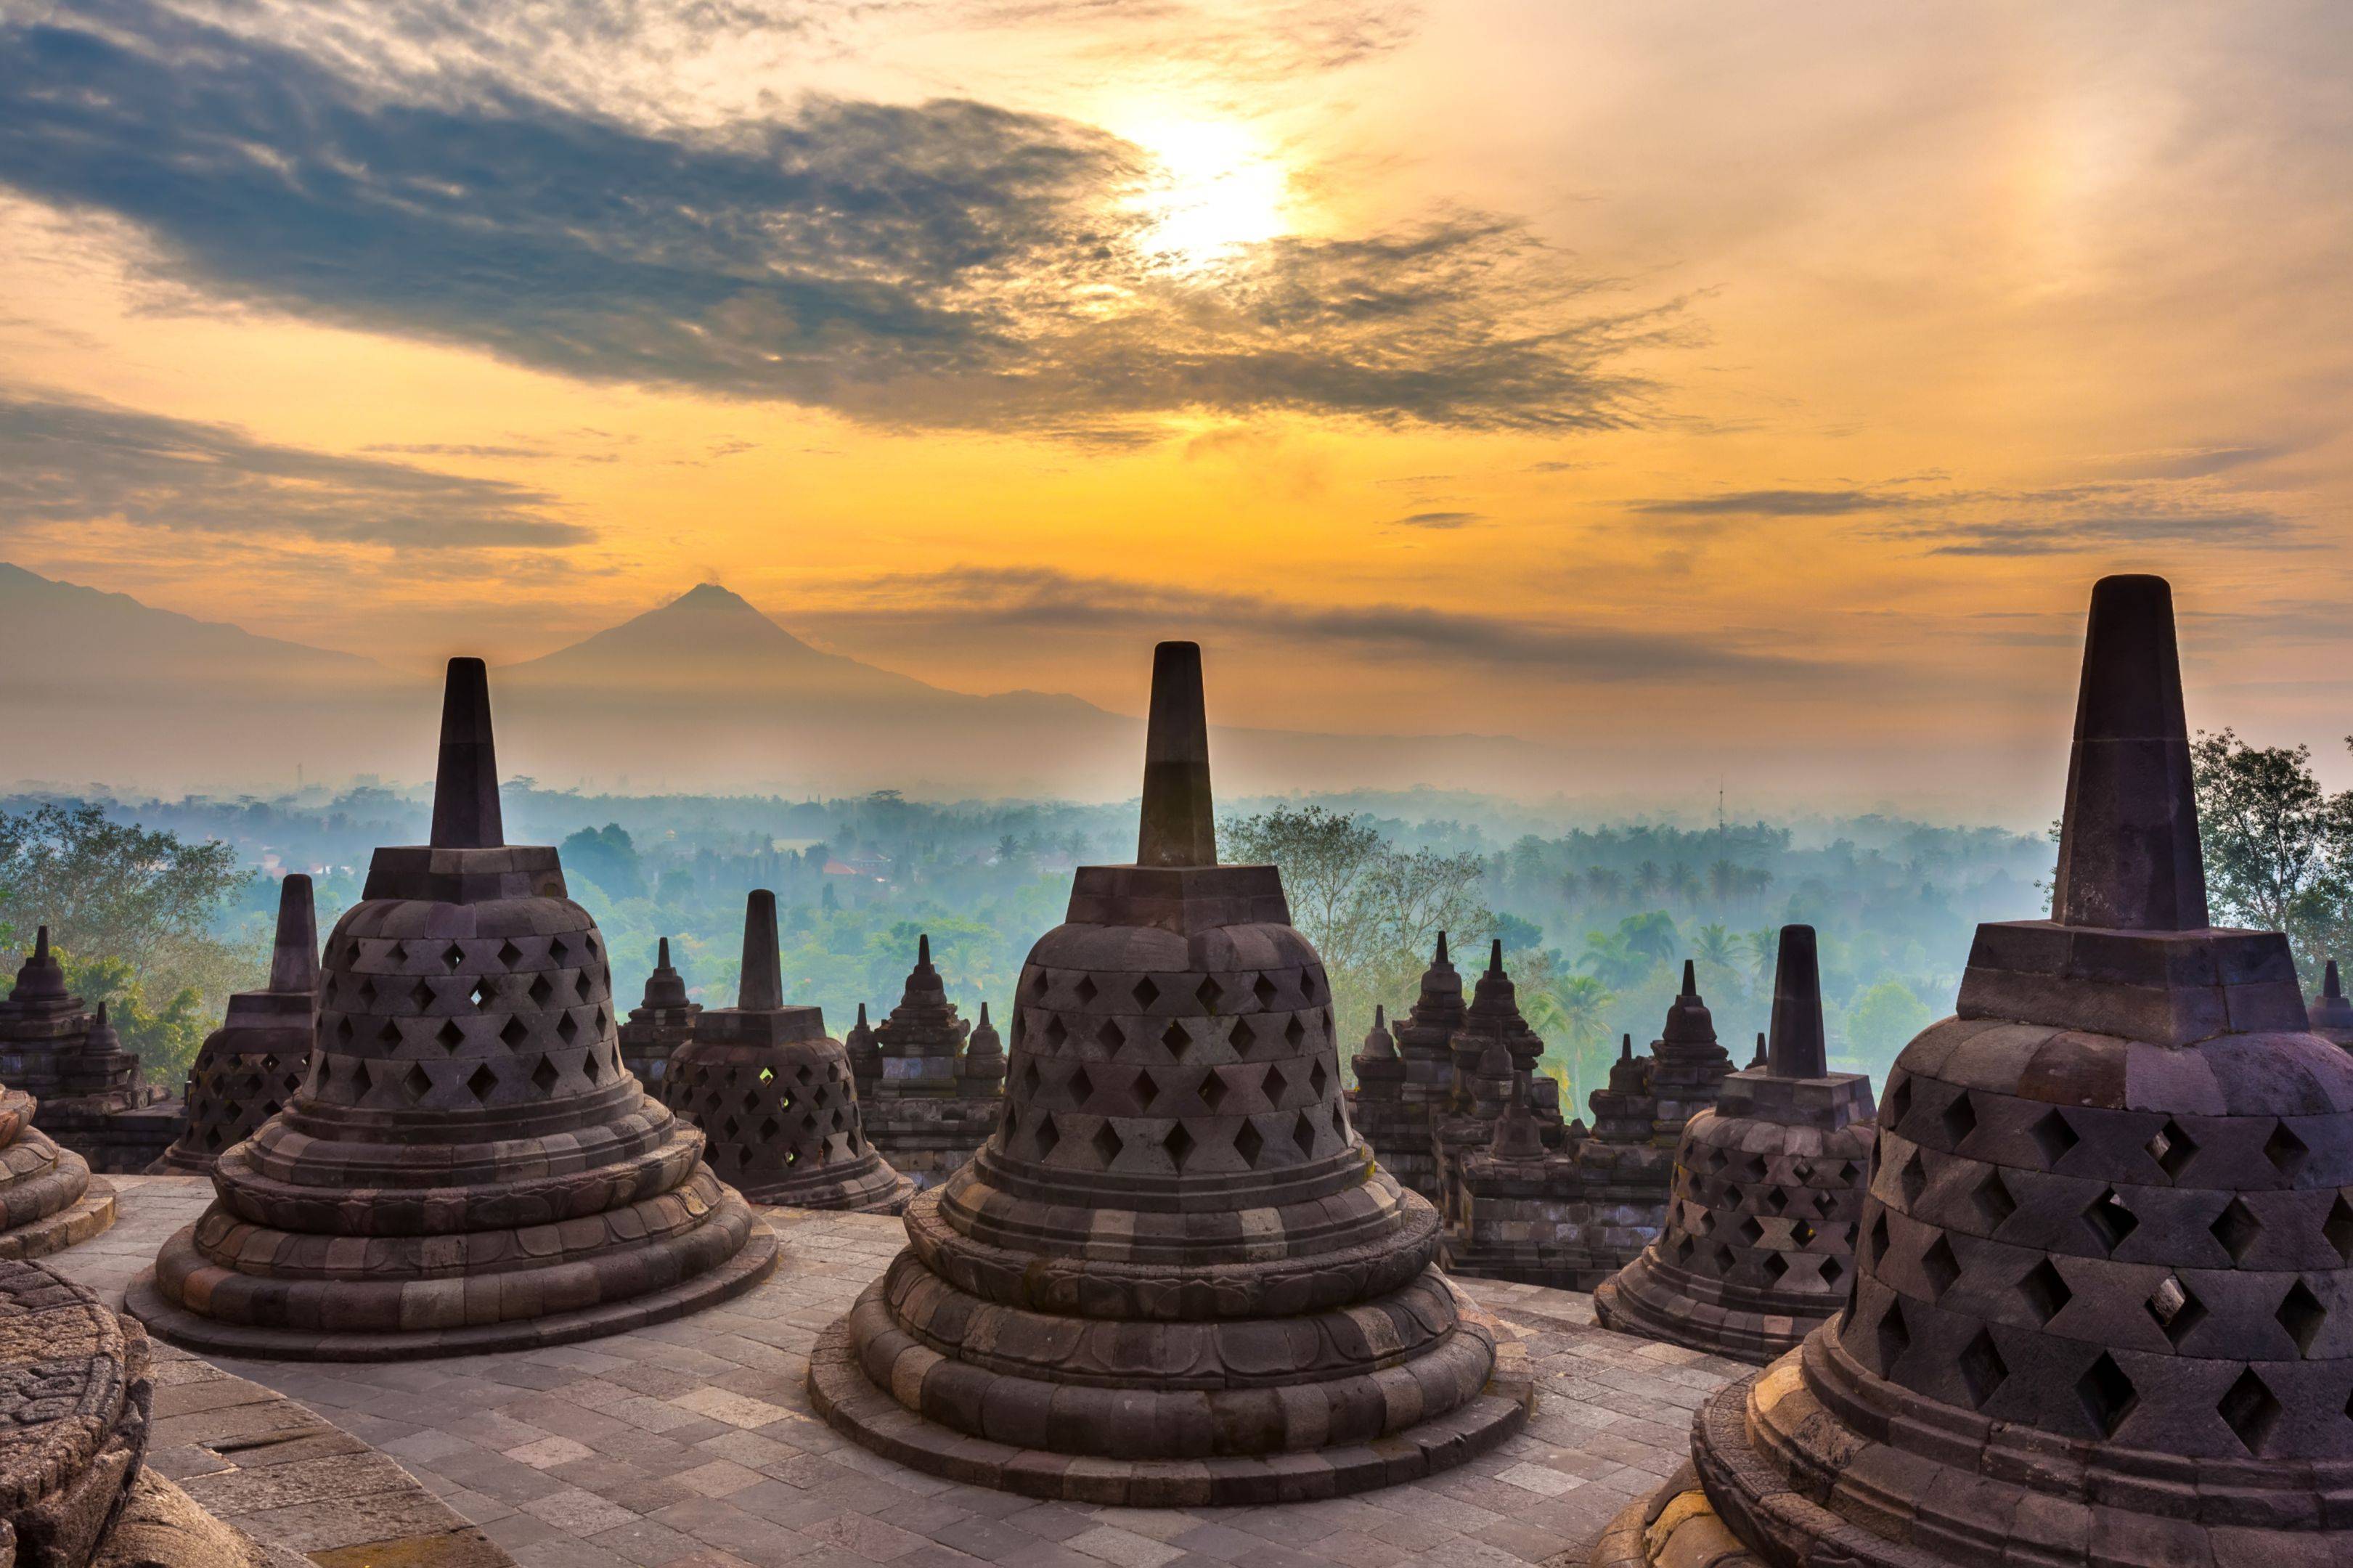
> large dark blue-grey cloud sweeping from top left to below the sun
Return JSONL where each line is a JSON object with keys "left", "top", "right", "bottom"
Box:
{"left": 0, "top": 0, "right": 1678, "bottom": 445}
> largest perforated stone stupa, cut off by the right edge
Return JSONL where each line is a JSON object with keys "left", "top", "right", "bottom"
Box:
{"left": 1595, "top": 577, "right": 2353, "bottom": 1568}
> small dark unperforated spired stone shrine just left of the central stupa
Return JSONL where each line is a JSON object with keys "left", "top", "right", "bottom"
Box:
{"left": 849, "top": 937, "right": 1005, "bottom": 1189}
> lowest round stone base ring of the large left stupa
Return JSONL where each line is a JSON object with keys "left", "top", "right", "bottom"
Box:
{"left": 123, "top": 1217, "right": 777, "bottom": 1361}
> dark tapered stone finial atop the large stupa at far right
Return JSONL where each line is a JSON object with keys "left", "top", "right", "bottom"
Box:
{"left": 2052, "top": 577, "right": 2209, "bottom": 930}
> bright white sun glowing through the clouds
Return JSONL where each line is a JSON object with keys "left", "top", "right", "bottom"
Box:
{"left": 1127, "top": 120, "right": 1292, "bottom": 273}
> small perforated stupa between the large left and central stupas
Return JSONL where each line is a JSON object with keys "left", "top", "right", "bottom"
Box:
{"left": 661, "top": 888, "right": 910, "bottom": 1215}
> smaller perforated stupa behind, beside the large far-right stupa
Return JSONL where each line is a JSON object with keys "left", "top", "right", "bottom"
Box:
{"left": 1593, "top": 926, "right": 1877, "bottom": 1363}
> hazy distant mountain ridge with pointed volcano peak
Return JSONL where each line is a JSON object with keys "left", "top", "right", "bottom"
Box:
{"left": 0, "top": 563, "right": 1549, "bottom": 798}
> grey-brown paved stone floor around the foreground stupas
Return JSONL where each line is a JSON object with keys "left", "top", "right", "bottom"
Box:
{"left": 52, "top": 1177, "right": 1746, "bottom": 1568}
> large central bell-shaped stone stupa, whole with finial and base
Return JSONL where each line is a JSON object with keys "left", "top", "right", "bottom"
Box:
{"left": 810, "top": 642, "right": 1530, "bottom": 1504}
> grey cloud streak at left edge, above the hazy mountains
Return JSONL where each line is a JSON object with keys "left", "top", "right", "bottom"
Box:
{"left": 0, "top": 388, "right": 593, "bottom": 551}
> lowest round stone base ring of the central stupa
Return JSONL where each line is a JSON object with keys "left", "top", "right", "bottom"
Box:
{"left": 810, "top": 1290, "right": 1534, "bottom": 1509}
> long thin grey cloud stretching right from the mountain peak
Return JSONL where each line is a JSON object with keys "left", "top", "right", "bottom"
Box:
{"left": 793, "top": 565, "right": 1807, "bottom": 680}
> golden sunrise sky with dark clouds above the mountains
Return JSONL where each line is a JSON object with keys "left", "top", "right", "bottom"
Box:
{"left": 0, "top": 0, "right": 2353, "bottom": 820}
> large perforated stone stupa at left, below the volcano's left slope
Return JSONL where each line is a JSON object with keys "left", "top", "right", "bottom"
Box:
{"left": 125, "top": 659, "right": 777, "bottom": 1358}
